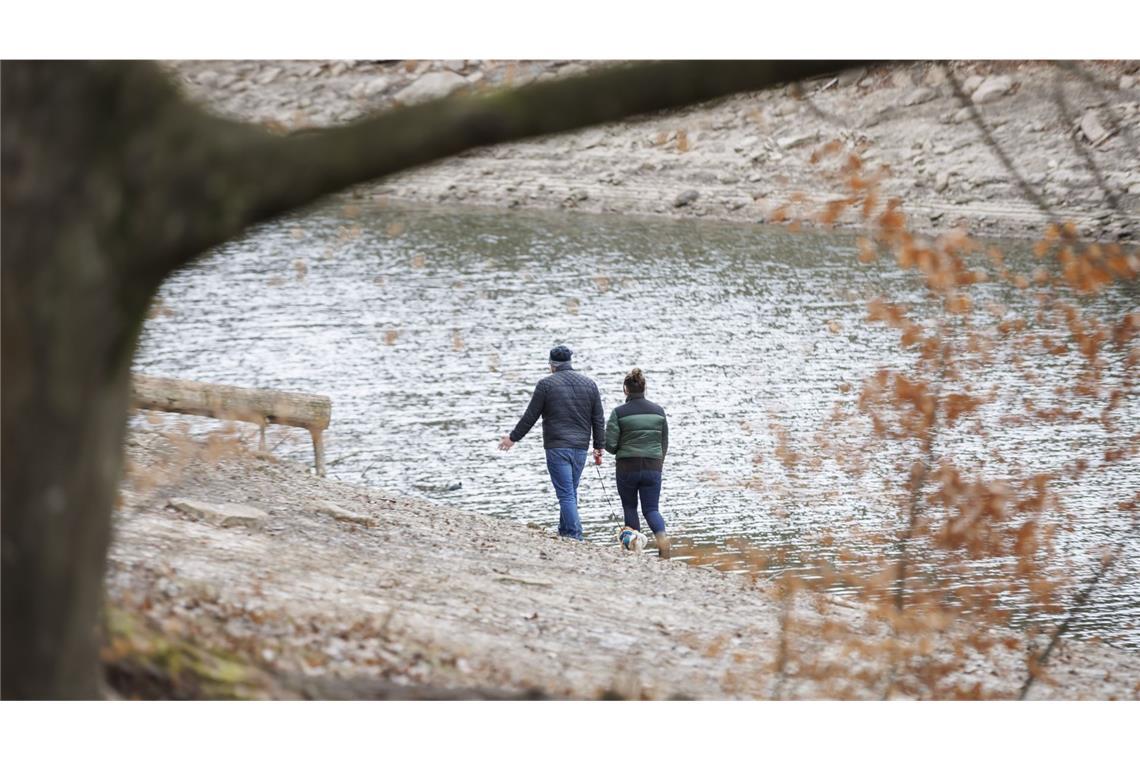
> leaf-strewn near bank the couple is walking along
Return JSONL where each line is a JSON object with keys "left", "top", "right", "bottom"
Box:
{"left": 107, "top": 431, "right": 1140, "bottom": 698}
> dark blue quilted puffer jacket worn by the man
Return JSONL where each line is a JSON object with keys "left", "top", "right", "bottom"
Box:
{"left": 511, "top": 362, "right": 605, "bottom": 449}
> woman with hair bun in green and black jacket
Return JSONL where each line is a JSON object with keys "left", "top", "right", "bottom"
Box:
{"left": 605, "top": 367, "right": 669, "bottom": 559}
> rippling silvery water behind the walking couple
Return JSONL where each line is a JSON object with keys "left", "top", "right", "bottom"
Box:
{"left": 136, "top": 199, "right": 1140, "bottom": 646}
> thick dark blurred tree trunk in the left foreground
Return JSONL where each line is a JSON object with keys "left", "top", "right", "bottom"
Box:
{"left": 0, "top": 63, "right": 157, "bottom": 698}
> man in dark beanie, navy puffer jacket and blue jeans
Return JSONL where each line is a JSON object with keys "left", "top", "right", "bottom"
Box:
{"left": 499, "top": 345, "right": 605, "bottom": 541}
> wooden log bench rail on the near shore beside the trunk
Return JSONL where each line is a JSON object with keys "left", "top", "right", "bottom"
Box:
{"left": 131, "top": 375, "right": 333, "bottom": 476}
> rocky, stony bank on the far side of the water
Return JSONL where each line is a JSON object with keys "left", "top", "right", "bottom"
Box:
{"left": 165, "top": 60, "right": 1140, "bottom": 240}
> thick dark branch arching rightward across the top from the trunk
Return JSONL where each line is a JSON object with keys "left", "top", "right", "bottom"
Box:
{"left": 156, "top": 62, "right": 848, "bottom": 273}
